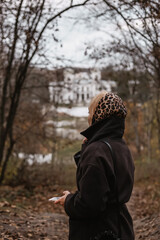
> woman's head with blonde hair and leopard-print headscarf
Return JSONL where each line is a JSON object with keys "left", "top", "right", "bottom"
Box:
{"left": 88, "top": 91, "right": 127, "bottom": 125}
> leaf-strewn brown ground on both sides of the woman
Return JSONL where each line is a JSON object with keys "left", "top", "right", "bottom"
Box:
{"left": 0, "top": 186, "right": 160, "bottom": 240}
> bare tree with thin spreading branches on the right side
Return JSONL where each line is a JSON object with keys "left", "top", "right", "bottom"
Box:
{"left": 83, "top": 0, "right": 160, "bottom": 154}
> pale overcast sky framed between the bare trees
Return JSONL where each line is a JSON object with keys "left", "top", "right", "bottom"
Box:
{"left": 32, "top": 0, "right": 138, "bottom": 68}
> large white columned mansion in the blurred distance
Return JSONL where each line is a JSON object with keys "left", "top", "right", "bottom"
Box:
{"left": 49, "top": 68, "right": 116, "bottom": 104}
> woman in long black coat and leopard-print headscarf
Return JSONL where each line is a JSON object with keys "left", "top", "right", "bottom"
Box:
{"left": 56, "top": 91, "right": 134, "bottom": 240}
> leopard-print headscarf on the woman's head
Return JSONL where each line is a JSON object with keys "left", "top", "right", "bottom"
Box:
{"left": 92, "top": 93, "right": 127, "bottom": 124}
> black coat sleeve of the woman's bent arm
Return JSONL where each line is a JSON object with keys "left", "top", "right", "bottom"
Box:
{"left": 64, "top": 158, "right": 110, "bottom": 219}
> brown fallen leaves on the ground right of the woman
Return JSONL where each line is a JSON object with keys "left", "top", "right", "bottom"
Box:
{"left": 128, "top": 183, "right": 160, "bottom": 240}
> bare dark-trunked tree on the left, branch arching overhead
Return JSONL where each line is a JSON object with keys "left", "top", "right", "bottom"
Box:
{"left": 0, "top": 0, "right": 89, "bottom": 183}
